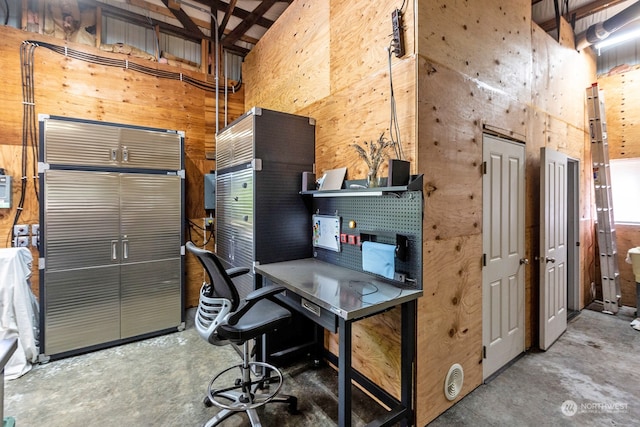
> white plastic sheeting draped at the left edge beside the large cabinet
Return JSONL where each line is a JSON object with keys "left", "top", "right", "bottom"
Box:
{"left": 0, "top": 248, "right": 38, "bottom": 379}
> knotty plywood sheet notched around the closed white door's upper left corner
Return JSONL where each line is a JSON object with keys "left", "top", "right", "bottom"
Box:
{"left": 418, "top": 56, "right": 527, "bottom": 244}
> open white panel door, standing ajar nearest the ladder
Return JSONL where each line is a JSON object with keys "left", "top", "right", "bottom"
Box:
{"left": 540, "top": 147, "right": 567, "bottom": 350}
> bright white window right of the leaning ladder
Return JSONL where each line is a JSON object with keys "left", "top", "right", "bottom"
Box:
{"left": 610, "top": 158, "right": 640, "bottom": 224}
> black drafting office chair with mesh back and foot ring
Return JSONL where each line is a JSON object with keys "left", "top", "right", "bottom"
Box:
{"left": 186, "top": 242, "right": 298, "bottom": 427}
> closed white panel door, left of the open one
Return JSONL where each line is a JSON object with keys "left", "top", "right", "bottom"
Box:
{"left": 482, "top": 135, "right": 526, "bottom": 379}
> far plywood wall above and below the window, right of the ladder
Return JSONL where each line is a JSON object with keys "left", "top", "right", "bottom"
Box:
{"left": 598, "top": 66, "right": 640, "bottom": 307}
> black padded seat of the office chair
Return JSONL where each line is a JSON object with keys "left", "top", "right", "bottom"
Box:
{"left": 218, "top": 299, "right": 291, "bottom": 343}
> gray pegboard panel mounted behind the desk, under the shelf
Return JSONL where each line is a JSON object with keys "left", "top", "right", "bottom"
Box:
{"left": 313, "top": 191, "right": 423, "bottom": 289}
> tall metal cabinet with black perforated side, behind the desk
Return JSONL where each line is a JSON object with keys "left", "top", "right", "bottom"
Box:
{"left": 216, "top": 107, "right": 315, "bottom": 296}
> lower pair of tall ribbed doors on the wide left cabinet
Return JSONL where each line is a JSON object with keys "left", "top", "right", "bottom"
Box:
{"left": 43, "top": 170, "right": 182, "bottom": 355}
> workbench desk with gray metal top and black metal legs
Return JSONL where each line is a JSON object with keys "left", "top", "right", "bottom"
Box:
{"left": 254, "top": 258, "right": 422, "bottom": 427}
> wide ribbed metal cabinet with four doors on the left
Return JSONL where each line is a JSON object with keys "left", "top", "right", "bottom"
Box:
{"left": 40, "top": 117, "right": 184, "bottom": 357}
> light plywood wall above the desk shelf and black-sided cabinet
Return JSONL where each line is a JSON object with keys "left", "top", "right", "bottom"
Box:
{"left": 243, "top": 0, "right": 417, "bottom": 179}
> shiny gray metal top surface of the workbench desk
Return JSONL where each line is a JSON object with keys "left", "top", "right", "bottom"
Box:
{"left": 254, "top": 258, "right": 422, "bottom": 320}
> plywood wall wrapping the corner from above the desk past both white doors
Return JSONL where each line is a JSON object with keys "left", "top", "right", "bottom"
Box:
{"left": 244, "top": 0, "right": 595, "bottom": 425}
